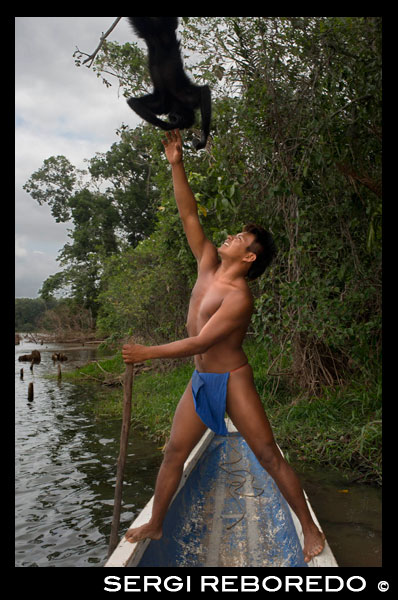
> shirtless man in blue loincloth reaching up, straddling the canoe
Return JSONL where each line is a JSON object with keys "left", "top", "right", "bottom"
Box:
{"left": 122, "top": 130, "right": 325, "bottom": 562}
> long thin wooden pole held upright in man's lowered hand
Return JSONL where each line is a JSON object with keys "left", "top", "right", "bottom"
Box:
{"left": 108, "top": 340, "right": 134, "bottom": 558}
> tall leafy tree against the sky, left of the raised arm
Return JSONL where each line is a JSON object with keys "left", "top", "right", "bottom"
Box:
{"left": 24, "top": 128, "right": 162, "bottom": 316}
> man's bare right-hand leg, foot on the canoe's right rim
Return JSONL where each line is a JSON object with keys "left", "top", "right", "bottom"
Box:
{"left": 227, "top": 365, "right": 325, "bottom": 562}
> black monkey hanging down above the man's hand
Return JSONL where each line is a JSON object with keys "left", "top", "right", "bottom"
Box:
{"left": 127, "top": 17, "right": 211, "bottom": 150}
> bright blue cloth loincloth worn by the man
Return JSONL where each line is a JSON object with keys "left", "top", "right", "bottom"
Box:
{"left": 192, "top": 369, "right": 229, "bottom": 435}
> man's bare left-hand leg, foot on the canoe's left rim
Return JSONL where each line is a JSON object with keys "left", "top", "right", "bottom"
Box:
{"left": 126, "top": 381, "right": 207, "bottom": 542}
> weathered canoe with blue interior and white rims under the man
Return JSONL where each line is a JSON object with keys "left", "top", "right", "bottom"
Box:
{"left": 105, "top": 419, "right": 338, "bottom": 568}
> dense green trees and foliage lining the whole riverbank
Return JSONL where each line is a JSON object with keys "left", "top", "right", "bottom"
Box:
{"left": 26, "top": 17, "right": 381, "bottom": 394}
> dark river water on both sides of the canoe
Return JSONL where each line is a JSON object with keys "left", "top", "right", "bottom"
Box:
{"left": 15, "top": 339, "right": 381, "bottom": 567}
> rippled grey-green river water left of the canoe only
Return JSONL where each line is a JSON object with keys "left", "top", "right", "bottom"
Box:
{"left": 15, "top": 344, "right": 161, "bottom": 567}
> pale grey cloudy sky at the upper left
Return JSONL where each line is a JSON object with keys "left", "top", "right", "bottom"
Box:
{"left": 15, "top": 17, "right": 138, "bottom": 298}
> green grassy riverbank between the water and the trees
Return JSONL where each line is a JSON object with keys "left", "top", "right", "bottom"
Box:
{"left": 64, "top": 343, "right": 382, "bottom": 485}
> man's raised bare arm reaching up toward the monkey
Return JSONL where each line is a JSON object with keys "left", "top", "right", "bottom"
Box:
{"left": 162, "top": 129, "right": 213, "bottom": 262}
